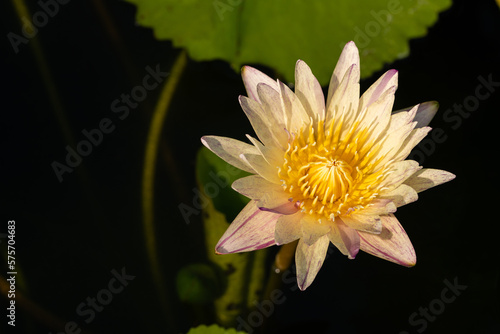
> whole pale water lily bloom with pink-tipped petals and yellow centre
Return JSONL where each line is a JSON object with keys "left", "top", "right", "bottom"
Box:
{"left": 202, "top": 42, "right": 455, "bottom": 290}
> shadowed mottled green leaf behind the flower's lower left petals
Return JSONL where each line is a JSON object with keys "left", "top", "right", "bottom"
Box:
{"left": 196, "top": 147, "right": 267, "bottom": 326}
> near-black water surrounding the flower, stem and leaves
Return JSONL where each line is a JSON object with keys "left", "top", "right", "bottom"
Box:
{"left": 0, "top": 1, "right": 500, "bottom": 333}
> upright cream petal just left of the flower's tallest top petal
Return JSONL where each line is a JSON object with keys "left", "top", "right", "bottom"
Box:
{"left": 295, "top": 60, "right": 325, "bottom": 120}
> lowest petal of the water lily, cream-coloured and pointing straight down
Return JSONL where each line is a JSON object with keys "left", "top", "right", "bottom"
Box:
{"left": 295, "top": 235, "right": 330, "bottom": 291}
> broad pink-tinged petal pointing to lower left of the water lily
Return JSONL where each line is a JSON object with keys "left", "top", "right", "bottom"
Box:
{"left": 215, "top": 201, "right": 281, "bottom": 254}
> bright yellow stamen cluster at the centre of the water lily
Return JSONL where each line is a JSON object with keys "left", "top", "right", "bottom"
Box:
{"left": 278, "top": 121, "right": 387, "bottom": 220}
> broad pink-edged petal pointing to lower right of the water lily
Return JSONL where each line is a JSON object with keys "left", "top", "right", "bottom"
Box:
{"left": 358, "top": 214, "right": 417, "bottom": 267}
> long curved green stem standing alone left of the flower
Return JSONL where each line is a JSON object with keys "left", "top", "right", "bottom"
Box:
{"left": 142, "top": 51, "right": 187, "bottom": 327}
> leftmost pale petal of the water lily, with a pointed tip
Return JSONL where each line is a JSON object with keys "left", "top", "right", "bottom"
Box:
{"left": 201, "top": 136, "right": 259, "bottom": 173}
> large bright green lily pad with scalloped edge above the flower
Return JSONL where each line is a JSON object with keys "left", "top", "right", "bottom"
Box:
{"left": 127, "top": 0, "right": 451, "bottom": 86}
